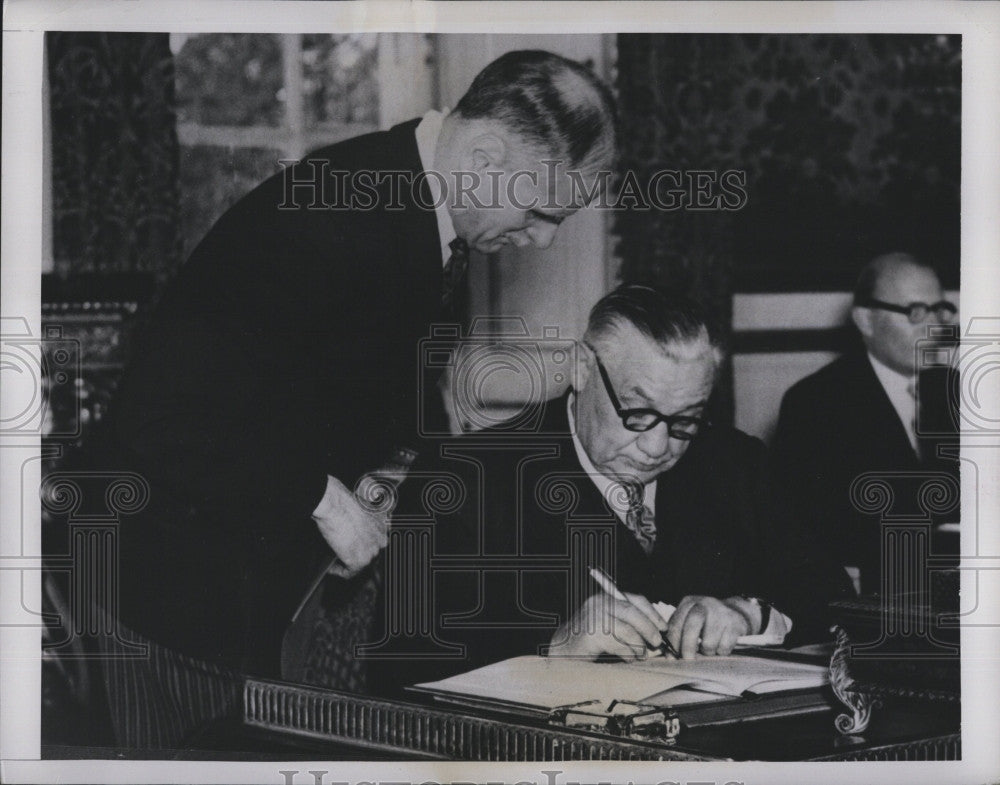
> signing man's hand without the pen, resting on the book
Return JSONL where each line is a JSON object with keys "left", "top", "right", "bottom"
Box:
{"left": 667, "top": 594, "right": 760, "bottom": 659}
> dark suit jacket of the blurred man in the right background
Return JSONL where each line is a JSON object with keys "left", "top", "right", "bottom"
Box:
{"left": 771, "top": 349, "right": 958, "bottom": 594}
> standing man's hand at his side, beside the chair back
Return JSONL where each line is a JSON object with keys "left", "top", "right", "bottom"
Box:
{"left": 312, "top": 476, "right": 389, "bottom": 578}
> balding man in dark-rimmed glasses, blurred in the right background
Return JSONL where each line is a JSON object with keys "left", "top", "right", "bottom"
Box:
{"left": 772, "top": 253, "right": 958, "bottom": 594}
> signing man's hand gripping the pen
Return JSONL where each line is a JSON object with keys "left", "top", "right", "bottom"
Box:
{"left": 549, "top": 592, "right": 667, "bottom": 660}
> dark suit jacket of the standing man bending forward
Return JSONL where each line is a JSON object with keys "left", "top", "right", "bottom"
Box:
{"left": 91, "top": 121, "right": 442, "bottom": 674}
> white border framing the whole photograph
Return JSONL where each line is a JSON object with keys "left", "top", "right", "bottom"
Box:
{"left": 0, "top": 0, "right": 1000, "bottom": 785}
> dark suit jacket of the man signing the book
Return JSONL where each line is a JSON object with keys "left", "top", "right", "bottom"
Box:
{"left": 370, "top": 396, "right": 850, "bottom": 684}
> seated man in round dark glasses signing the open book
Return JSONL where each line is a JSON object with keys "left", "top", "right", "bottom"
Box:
{"left": 376, "top": 285, "right": 849, "bottom": 680}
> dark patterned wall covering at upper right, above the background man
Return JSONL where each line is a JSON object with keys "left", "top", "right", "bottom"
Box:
{"left": 616, "top": 35, "right": 961, "bottom": 304}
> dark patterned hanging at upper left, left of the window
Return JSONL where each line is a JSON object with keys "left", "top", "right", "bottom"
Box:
{"left": 46, "top": 33, "right": 180, "bottom": 277}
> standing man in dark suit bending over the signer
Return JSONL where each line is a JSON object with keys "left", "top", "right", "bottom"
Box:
{"left": 84, "top": 51, "right": 615, "bottom": 747}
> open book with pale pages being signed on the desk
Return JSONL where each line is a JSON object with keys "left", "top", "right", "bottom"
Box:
{"left": 414, "top": 656, "right": 829, "bottom": 711}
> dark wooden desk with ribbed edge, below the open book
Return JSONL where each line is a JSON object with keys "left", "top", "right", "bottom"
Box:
{"left": 234, "top": 680, "right": 961, "bottom": 761}
